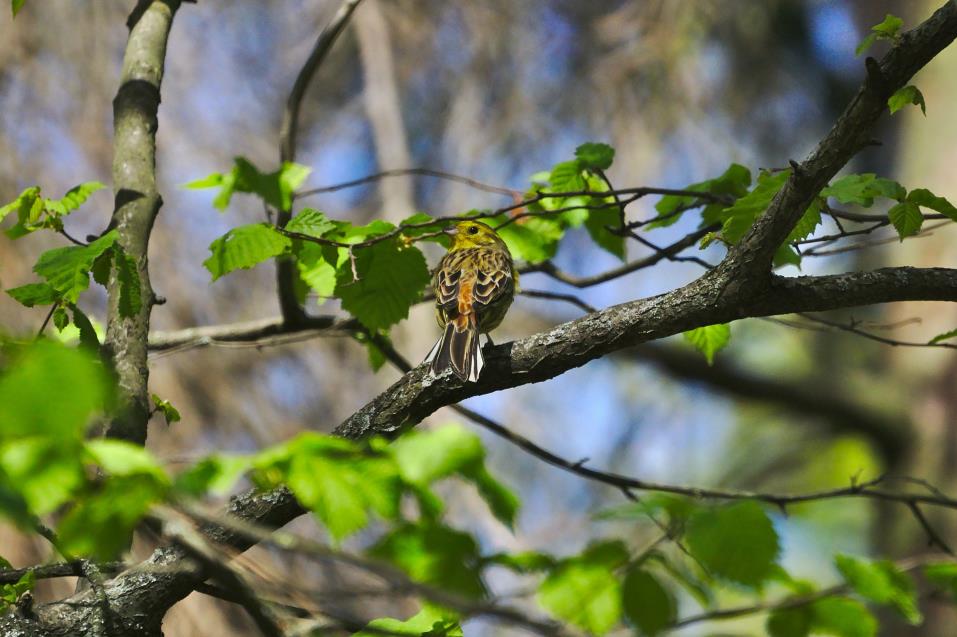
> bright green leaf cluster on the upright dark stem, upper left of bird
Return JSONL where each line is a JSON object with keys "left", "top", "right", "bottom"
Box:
{"left": 185, "top": 157, "right": 312, "bottom": 210}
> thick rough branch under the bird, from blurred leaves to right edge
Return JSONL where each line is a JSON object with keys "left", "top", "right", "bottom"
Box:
{"left": 335, "top": 267, "right": 957, "bottom": 438}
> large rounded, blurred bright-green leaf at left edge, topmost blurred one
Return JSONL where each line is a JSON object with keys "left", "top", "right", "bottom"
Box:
{"left": 0, "top": 341, "right": 111, "bottom": 442}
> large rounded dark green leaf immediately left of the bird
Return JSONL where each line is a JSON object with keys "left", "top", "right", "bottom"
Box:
{"left": 335, "top": 239, "right": 429, "bottom": 332}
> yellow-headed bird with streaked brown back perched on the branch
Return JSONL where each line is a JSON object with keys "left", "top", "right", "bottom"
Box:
{"left": 424, "top": 221, "right": 518, "bottom": 382}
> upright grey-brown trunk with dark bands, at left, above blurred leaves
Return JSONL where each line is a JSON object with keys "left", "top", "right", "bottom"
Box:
{"left": 105, "top": 0, "right": 180, "bottom": 444}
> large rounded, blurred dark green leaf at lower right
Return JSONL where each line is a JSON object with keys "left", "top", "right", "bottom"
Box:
{"left": 685, "top": 501, "right": 780, "bottom": 587}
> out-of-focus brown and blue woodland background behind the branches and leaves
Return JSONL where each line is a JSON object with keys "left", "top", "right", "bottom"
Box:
{"left": 0, "top": 0, "right": 957, "bottom": 636}
